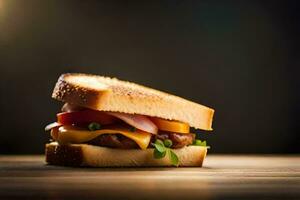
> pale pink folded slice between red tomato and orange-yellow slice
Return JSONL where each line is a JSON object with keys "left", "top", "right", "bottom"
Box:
{"left": 107, "top": 112, "right": 158, "bottom": 135}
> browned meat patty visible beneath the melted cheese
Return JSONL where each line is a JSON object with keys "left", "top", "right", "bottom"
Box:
{"left": 88, "top": 132, "right": 195, "bottom": 149}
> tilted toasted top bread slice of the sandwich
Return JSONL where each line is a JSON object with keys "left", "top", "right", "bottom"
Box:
{"left": 52, "top": 73, "right": 214, "bottom": 130}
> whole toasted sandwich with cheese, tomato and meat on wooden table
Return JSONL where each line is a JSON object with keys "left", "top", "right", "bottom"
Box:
{"left": 45, "top": 73, "right": 214, "bottom": 167}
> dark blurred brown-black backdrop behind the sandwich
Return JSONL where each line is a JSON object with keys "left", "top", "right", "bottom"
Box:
{"left": 0, "top": 0, "right": 300, "bottom": 154}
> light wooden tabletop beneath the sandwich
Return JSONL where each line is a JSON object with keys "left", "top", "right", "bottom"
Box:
{"left": 0, "top": 155, "right": 300, "bottom": 200}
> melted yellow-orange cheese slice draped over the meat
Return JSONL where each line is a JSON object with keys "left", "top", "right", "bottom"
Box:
{"left": 54, "top": 126, "right": 151, "bottom": 149}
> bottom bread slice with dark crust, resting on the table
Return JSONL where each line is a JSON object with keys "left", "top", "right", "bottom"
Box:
{"left": 46, "top": 142, "right": 207, "bottom": 167}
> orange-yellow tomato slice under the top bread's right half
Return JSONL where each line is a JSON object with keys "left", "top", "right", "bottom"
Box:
{"left": 151, "top": 117, "right": 190, "bottom": 133}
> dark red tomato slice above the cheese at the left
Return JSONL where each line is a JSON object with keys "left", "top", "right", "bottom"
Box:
{"left": 56, "top": 110, "right": 116, "bottom": 125}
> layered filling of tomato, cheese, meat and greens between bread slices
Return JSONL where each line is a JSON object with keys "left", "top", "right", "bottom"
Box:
{"left": 45, "top": 103, "right": 206, "bottom": 165}
